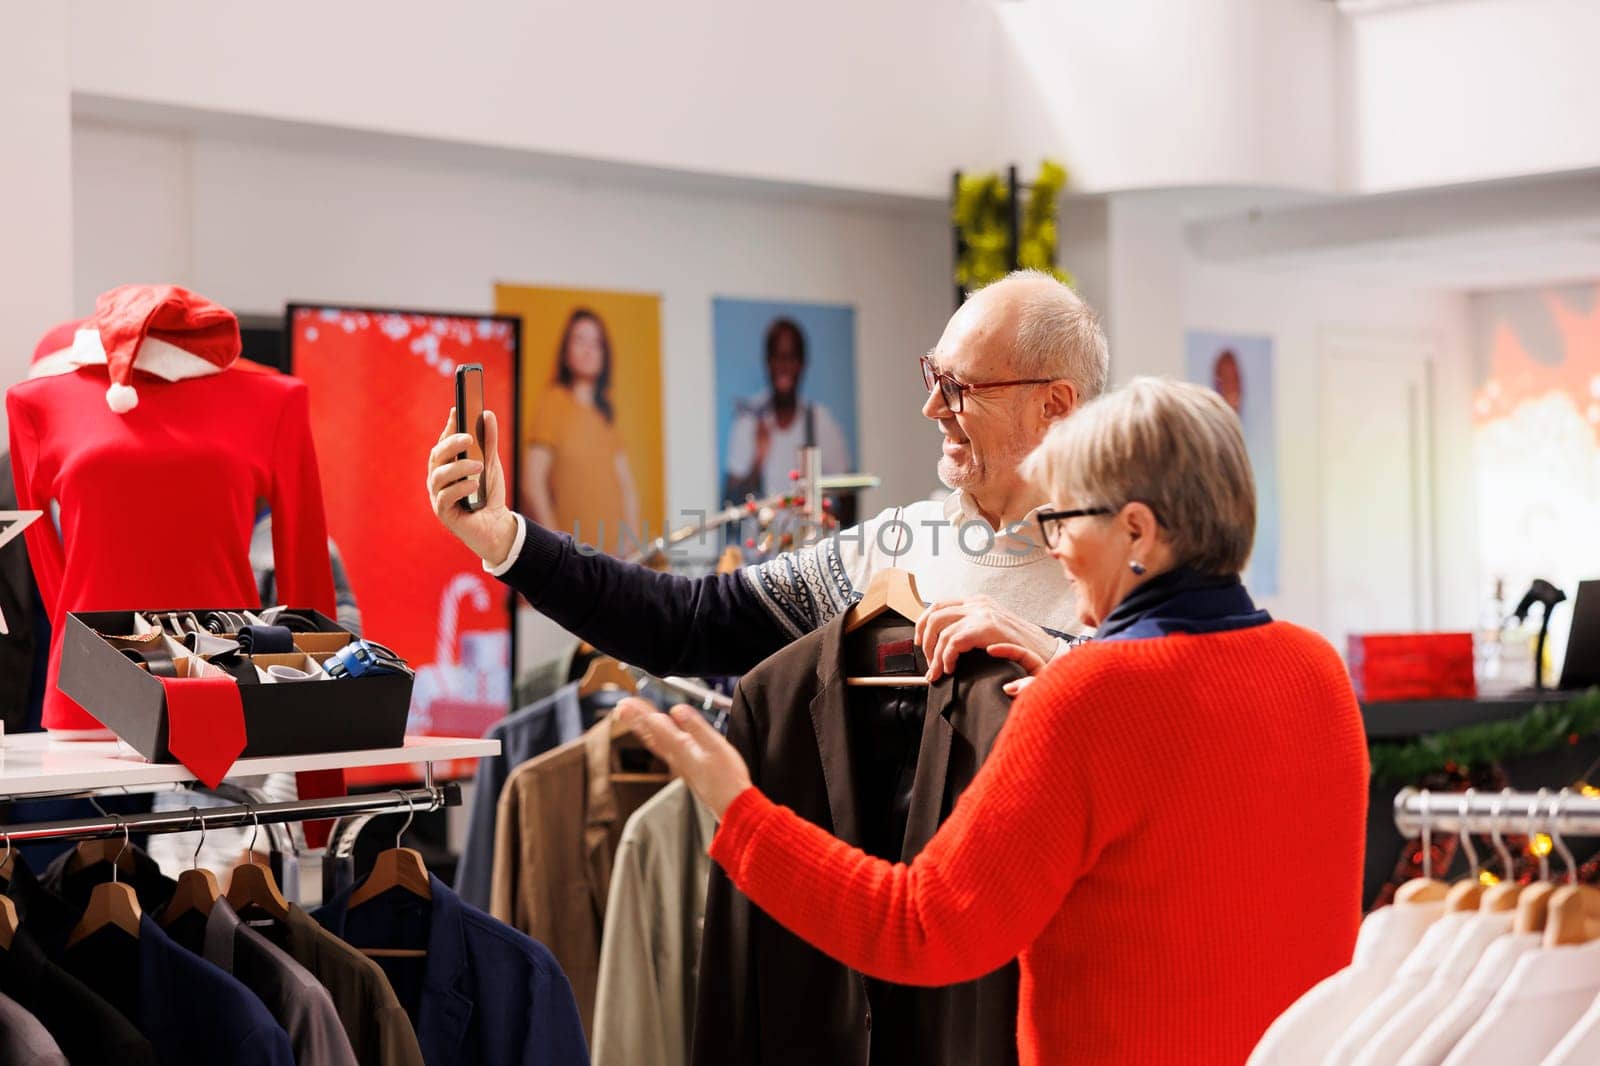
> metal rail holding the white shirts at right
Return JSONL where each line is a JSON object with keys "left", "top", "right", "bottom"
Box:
{"left": 1395, "top": 787, "right": 1600, "bottom": 837}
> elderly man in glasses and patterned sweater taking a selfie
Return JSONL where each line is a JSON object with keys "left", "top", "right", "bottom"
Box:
{"left": 427, "top": 271, "right": 1107, "bottom": 679}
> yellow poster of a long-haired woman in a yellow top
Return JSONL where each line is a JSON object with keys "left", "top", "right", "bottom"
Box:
{"left": 494, "top": 285, "right": 666, "bottom": 557}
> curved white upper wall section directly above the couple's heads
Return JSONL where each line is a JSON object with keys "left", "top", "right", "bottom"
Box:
{"left": 994, "top": 0, "right": 1339, "bottom": 192}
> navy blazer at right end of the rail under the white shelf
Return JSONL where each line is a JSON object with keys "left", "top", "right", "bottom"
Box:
{"left": 314, "top": 876, "right": 589, "bottom": 1066}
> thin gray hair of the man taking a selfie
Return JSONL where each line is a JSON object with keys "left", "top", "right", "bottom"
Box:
{"left": 994, "top": 271, "right": 1110, "bottom": 403}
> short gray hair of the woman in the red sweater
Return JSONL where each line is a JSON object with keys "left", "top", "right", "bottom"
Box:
{"left": 1022, "top": 378, "right": 1256, "bottom": 576}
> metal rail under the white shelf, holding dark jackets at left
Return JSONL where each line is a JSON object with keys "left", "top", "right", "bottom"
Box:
{"left": 0, "top": 783, "right": 461, "bottom": 844}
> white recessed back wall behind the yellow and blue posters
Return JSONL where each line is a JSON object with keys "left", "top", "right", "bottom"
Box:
{"left": 74, "top": 123, "right": 950, "bottom": 524}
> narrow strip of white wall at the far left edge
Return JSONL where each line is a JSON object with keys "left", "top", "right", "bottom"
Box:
{"left": 0, "top": 3, "right": 72, "bottom": 444}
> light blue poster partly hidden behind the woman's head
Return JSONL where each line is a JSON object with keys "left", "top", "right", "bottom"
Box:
{"left": 1186, "top": 330, "right": 1278, "bottom": 595}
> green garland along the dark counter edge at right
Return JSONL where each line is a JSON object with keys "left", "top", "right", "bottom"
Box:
{"left": 1370, "top": 688, "right": 1600, "bottom": 784}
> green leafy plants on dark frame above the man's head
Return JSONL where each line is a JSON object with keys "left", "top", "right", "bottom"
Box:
{"left": 950, "top": 158, "right": 1072, "bottom": 288}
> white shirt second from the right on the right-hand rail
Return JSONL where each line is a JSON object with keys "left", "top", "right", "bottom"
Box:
{"left": 1445, "top": 941, "right": 1600, "bottom": 1066}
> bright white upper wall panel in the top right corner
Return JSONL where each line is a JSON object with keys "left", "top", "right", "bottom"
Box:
{"left": 1344, "top": 0, "right": 1600, "bottom": 190}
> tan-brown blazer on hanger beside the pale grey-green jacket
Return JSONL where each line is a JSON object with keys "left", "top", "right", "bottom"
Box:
{"left": 490, "top": 719, "right": 661, "bottom": 1042}
